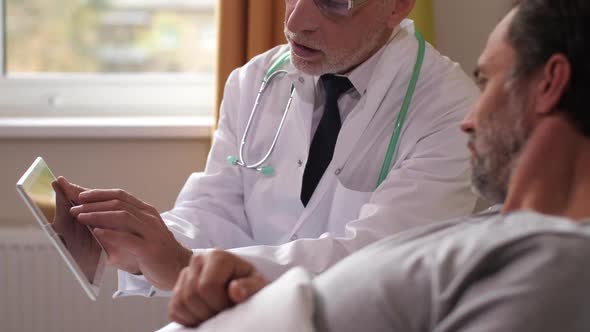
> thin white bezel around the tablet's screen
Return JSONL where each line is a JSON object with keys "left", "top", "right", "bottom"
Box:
{"left": 16, "top": 157, "right": 107, "bottom": 301}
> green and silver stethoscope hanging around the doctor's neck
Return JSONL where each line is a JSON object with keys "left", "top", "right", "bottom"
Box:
{"left": 227, "top": 31, "right": 426, "bottom": 186}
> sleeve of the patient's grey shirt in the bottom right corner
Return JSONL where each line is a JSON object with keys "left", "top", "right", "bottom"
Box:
{"left": 430, "top": 234, "right": 590, "bottom": 332}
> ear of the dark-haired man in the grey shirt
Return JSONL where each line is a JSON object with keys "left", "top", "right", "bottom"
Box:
{"left": 534, "top": 54, "right": 571, "bottom": 116}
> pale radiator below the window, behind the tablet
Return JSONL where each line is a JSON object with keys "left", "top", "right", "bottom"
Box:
{"left": 0, "top": 228, "right": 167, "bottom": 332}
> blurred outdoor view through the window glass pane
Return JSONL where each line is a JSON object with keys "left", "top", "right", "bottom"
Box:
{"left": 5, "top": 0, "right": 216, "bottom": 76}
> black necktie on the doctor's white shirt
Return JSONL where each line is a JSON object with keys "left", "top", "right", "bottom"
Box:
{"left": 301, "top": 74, "right": 352, "bottom": 206}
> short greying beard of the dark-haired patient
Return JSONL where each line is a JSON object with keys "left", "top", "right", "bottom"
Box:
{"left": 471, "top": 89, "right": 531, "bottom": 204}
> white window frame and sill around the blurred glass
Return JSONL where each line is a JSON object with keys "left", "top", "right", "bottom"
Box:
{"left": 0, "top": 0, "right": 216, "bottom": 138}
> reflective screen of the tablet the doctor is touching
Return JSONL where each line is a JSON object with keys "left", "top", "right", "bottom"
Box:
{"left": 23, "top": 163, "right": 102, "bottom": 284}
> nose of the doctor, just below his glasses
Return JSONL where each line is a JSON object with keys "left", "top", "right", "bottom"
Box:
{"left": 285, "top": 0, "right": 322, "bottom": 33}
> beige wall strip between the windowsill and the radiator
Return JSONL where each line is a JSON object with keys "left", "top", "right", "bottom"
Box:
{"left": 0, "top": 139, "right": 209, "bottom": 227}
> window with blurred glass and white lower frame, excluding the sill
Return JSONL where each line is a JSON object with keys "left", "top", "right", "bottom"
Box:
{"left": 0, "top": 0, "right": 216, "bottom": 118}
